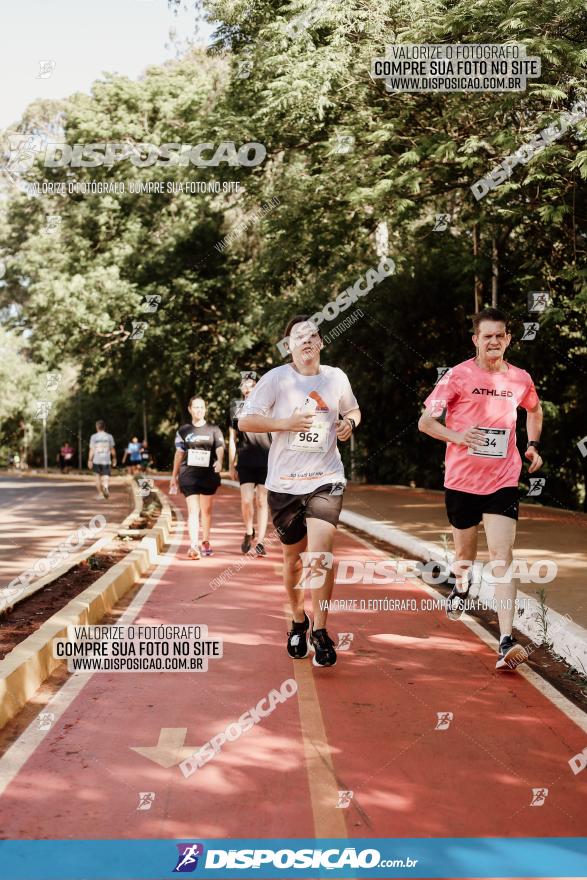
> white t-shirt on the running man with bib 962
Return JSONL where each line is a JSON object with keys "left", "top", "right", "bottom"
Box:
{"left": 240, "top": 364, "right": 358, "bottom": 495}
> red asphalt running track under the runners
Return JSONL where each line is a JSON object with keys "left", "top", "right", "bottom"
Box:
{"left": 0, "top": 481, "right": 587, "bottom": 852}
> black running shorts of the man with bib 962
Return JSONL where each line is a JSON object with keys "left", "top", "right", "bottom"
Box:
{"left": 267, "top": 483, "right": 344, "bottom": 544}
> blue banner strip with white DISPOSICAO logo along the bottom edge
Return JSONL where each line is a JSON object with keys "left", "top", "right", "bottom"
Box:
{"left": 0, "top": 837, "right": 587, "bottom": 880}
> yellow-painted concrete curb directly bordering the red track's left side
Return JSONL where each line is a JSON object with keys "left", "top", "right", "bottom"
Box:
{"left": 0, "top": 488, "right": 172, "bottom": 728}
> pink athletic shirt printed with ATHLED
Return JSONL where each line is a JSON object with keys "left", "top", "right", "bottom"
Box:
{"left": 425, "top": 358, "right": 539, "bottom": 495}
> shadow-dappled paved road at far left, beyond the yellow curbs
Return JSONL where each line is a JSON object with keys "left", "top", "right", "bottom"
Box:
{"left": 0, "top": 475, "right": 133, "bottom": 586}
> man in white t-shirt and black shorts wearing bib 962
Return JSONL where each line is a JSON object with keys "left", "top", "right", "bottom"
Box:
{"left": 238, "top": 315, "right": 361, "bottom": 666}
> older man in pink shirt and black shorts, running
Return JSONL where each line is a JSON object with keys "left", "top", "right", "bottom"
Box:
{"left": 418, "top": 309, "right": 542, "bottom": 669}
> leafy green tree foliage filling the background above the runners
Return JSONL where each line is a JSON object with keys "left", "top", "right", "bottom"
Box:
{"left": 0, "top": 0, "right": 587, "bottom": 506}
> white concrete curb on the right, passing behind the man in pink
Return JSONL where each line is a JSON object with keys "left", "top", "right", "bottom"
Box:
{"left": 340, "top": 510, "right": 587, "bottom": 673}
